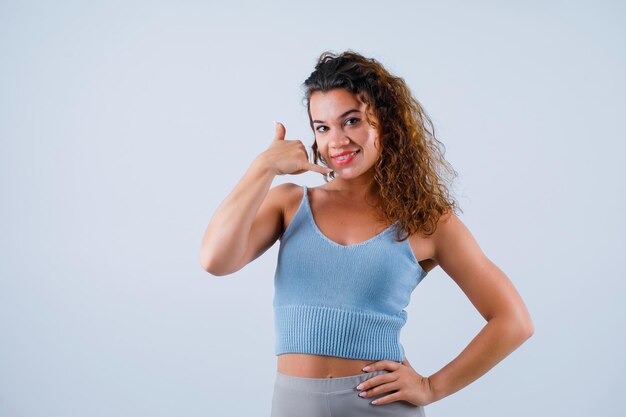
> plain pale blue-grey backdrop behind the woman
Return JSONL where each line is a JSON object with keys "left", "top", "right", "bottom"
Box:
{"left": 0, "top": 0, "right": 626, "bottom": 417}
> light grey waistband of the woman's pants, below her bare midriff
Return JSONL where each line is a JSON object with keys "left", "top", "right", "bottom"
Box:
{"left": 275, "top": 369, "right": 390, "bottom": 393}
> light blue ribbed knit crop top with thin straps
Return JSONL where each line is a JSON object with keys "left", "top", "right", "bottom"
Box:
{"left": 273, "top": 186, "right": 427, "bottom": 362}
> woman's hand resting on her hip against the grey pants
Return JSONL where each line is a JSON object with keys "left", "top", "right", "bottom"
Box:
{"left": 357, "top": 358, "right": 434, "bottom": 406}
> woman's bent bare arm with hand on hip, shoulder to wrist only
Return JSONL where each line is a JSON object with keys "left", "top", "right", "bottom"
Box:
{"left": 428, "top": 213, "right": 534, "bottom": 401}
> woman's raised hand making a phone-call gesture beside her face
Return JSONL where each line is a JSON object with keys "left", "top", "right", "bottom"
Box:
{"left": 260, "top": 123, "right": 332, "bottom": 175}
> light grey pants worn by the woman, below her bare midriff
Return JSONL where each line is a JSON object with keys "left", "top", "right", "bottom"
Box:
{"left": 271, "top": 369, "right": 425, "bottom": 417}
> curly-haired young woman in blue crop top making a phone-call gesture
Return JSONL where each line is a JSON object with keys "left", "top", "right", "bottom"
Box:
{"left": 200, "top": 51, "right": 534, "bottom": 417}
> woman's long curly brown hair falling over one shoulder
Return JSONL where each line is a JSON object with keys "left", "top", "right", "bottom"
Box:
{"left": 303, "top": 50, "right": 462, "bottom": 241}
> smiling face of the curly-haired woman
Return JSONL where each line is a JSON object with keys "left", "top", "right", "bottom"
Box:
{"left": 309, "top": 88, "right": 379, "bottom": 179}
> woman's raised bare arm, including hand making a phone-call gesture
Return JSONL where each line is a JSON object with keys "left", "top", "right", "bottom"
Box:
{"left": 200, "top": 124, "right": 329, "bottom": 276}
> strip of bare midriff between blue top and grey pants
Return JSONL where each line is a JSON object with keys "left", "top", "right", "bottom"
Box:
{"left": 277, "top": 353, "right": 377, "bottom": 378}
